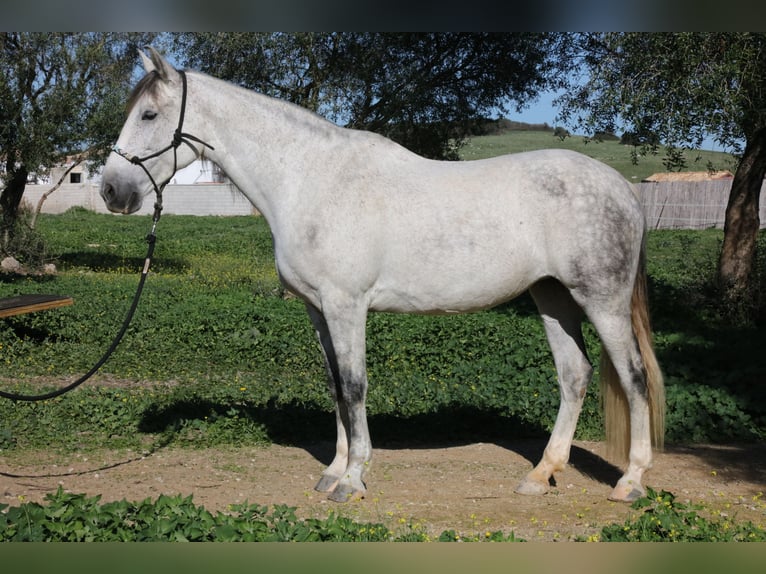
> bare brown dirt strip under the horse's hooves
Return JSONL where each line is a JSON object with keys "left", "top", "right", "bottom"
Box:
{"left": 0, "top": 441, "right": 766, "bottom": 541}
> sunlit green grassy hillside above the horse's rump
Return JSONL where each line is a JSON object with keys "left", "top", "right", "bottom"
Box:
{"left": 460, "top": 130, "right": 735, "bottom": 183}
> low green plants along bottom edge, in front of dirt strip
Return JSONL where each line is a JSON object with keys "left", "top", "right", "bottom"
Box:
{"left": 0, "top": 487, "right": 766, "bottom": 542}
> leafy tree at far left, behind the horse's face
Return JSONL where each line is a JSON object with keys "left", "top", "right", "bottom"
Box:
{"left": 0, "top": 32, "right": 156, "bottom": 251}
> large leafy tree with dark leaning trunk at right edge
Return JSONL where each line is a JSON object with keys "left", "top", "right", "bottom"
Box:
{"left": 560, "top": 33, "right": 766, "bottom": 318}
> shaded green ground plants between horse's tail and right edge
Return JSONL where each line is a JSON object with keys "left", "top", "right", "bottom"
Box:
{"left": 648, "top": 230, "right": 766, "bottom": 442}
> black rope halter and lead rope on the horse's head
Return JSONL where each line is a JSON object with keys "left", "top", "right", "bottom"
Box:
{"left": 0, "top": 70, "right": 215, "bottom": 402}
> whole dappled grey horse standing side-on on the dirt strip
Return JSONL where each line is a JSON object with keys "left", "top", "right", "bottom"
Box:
{"left": 101, "top": 48, "right": 664, "bottom": 508}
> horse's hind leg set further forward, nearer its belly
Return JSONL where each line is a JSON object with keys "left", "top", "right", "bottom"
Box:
{"left": 516, "top": 279, "right": 593, "bottom": 494}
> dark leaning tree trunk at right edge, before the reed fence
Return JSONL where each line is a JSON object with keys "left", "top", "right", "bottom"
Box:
{"left": 718, "top": 129, "right": 766, "bottom": 312}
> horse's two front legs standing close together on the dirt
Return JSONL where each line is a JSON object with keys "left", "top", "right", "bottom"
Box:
{"left": 307, "top": 306, "right": 372, "bottom": 502}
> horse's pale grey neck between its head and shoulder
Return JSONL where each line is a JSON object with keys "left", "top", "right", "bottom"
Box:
{"left": 189, "top": 71, "right": 340, "bottom": 223}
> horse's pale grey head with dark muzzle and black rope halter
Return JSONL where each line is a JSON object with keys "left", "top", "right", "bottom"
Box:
{"left": 101, "top": 48, "right": 198, "bottom": 213}
